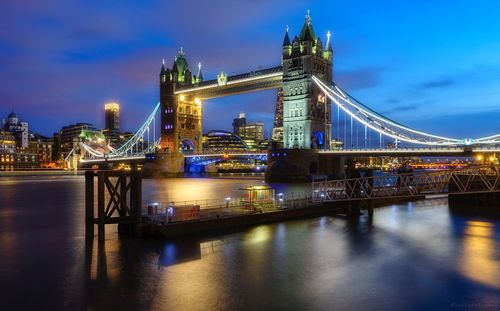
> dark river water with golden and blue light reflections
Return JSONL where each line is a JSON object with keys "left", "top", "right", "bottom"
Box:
{"left": 0, "top": 176, "right": 500, "bottom": 310}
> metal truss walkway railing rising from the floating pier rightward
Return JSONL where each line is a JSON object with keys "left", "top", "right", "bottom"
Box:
{"left": 312, "top": 165, "right": 500, "bottom": 202}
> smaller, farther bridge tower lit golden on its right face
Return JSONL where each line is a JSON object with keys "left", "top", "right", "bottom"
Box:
{"left": 160, "top": 48, "right": 203, "bottom": 154}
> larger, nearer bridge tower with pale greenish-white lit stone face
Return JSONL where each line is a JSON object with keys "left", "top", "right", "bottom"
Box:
{"left": 282, "top": 12, "right": 333, "bottom": 149}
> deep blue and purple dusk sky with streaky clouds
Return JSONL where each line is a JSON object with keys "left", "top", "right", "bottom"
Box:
{"left": 0, "top": 0, "right": 500, "bottom": 138}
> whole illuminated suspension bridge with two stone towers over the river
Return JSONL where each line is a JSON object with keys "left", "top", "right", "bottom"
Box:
{"left": 75, "top": 13, "right": 500, "bottom": 180}
